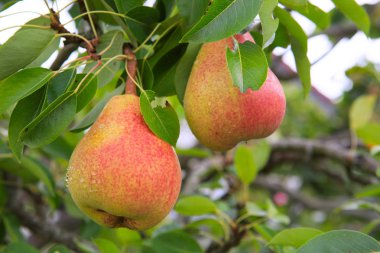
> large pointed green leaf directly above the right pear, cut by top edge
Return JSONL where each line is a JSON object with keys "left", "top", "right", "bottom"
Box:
{"left": 182, "top": 0, "right": 262, "bottom": 43}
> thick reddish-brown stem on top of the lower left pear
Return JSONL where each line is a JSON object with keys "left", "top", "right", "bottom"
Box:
{"left": 123, "top": 43, "right": 137, "bottom": 95}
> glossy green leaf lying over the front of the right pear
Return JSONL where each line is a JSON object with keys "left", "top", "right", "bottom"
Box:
{"left": 226, "top": 41, "right": 268, "bottom": 92}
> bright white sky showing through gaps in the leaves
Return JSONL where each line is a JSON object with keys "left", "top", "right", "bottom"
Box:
{"left": 0, "top": 0, "right": 380, "bottom": 100}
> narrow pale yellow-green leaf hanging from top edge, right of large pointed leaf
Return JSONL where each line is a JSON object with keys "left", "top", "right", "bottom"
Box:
{"left": 259, "top": 0, "right": 279, "bottom": 48}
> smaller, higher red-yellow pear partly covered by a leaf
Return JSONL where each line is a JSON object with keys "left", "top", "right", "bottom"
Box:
{"left": 184, "top": 33, "right": 286, "bottom": 151}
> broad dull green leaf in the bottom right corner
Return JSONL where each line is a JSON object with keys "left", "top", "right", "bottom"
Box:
{"left": 296, "top": 230, "right": 380, "bottom": 253}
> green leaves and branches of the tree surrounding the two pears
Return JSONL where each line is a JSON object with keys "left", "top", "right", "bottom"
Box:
{"left": 0, "top": 0, "right": 380, "bottom": 253}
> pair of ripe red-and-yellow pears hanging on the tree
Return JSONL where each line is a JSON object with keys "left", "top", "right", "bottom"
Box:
{"left": 67, "top": 33, "right": 286, "bottom": 230}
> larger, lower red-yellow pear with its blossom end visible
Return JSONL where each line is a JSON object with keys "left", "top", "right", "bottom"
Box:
{"left": 67, "top": 94, "right": 181, "bottom": 230}
